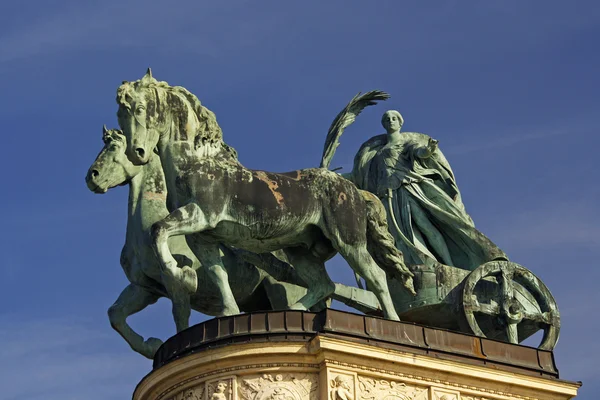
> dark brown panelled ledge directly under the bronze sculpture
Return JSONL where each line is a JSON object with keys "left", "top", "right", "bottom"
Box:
{"left": 153, "top": 309, "right": 558, "bottom": 379}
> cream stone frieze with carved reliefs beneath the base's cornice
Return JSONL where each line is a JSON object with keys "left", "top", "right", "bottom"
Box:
{"left": 148, "top": 359, "right": 560, "bottom": 400}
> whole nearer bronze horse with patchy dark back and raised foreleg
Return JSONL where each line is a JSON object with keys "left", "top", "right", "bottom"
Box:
{"left": 117, "top": 70, "right": 414, "bottom": 320}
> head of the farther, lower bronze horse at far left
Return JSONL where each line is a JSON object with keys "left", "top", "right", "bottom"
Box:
{"left": 85, "top": 126, "right": 141, "bottom": 193}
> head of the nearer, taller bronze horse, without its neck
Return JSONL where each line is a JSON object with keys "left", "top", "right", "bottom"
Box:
{"left": 117, "top": 68, "right": 166, "bottom": 165}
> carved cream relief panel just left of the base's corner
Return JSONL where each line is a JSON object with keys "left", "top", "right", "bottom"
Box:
{"left": 238, "top": 373, "right": 319, "bottom": 400}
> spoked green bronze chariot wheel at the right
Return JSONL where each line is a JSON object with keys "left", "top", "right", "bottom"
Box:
{"left": 462, "top": 261, "right": 560, "bottom": 350}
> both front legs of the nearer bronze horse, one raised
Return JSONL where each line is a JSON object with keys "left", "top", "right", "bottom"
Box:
{"left": 152, "top": 203, "right": 240, "bottom": 315}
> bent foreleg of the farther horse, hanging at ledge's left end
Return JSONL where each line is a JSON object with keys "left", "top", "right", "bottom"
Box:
{"left": 108, "top": 284, "right": 162, "bottom": 359}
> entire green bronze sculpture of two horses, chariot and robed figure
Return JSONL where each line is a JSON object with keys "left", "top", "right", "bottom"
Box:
{"left": 86, "top": 70, "right": 560, "bottom": 356}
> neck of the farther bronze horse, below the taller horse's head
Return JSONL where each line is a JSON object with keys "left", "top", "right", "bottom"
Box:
{"left": 127, "top": 154, "right": 168, "bottom": 233}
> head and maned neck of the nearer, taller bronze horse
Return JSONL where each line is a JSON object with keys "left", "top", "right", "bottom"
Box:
{"left": 117, "top": 69, "right": 237, "bottom": 165}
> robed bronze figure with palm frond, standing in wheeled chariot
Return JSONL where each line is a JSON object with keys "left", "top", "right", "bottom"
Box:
{"left": 321, "top": 106, "right": 560, "bottom": 349}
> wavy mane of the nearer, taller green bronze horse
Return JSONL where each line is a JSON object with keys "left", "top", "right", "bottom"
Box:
{"left": 117, "top": 72, "right": 238, "bottom": 161}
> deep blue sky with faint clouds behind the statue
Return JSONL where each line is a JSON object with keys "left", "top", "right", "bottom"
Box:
{"left": 0, "top": 0, "right": 600, "bottom": 400}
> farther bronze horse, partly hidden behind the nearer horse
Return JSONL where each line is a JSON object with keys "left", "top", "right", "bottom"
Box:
{"left": 86, "top": 128, "right": 326, "bottom": 358}
